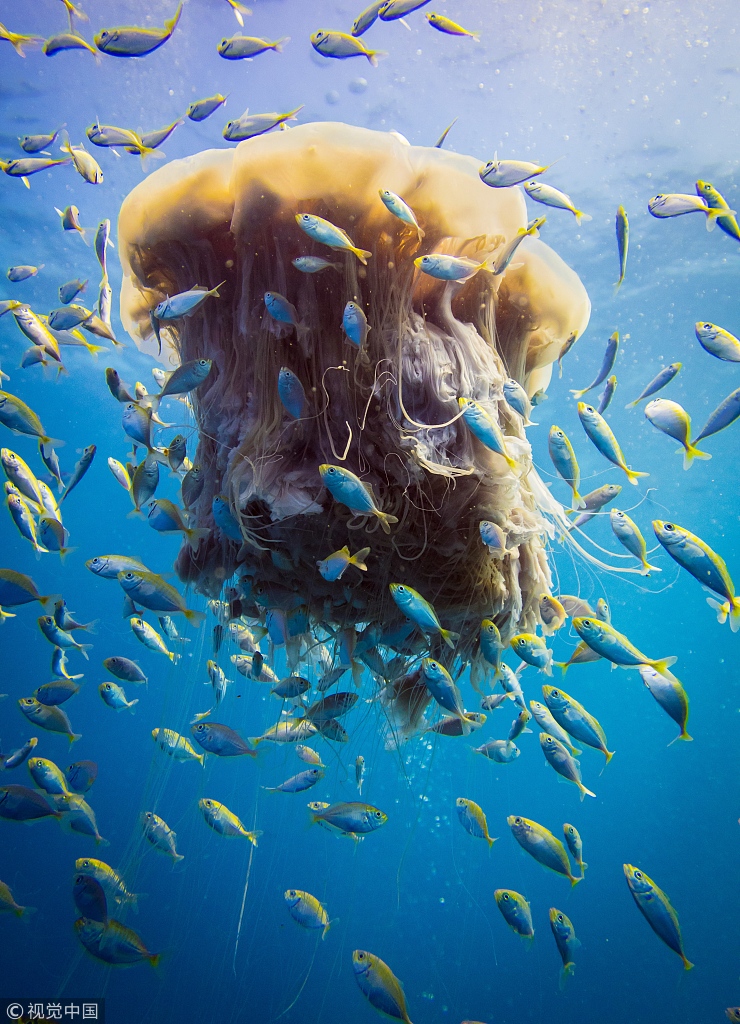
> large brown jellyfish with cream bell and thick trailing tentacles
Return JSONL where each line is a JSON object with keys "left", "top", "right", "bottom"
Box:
{"left": 119, "top": 123, "right": 590, "bottom": 656}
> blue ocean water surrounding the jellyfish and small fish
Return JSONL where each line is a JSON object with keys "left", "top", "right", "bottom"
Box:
{"left": 0, "top": 0, "right": 740, "bottom": 1024}
